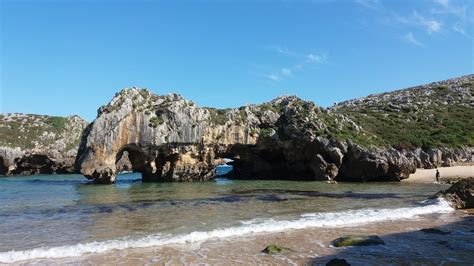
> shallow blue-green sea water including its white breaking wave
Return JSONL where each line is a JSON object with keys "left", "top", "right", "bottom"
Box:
{"left": 0, "top": 170, "right": 468, "bottom": 262}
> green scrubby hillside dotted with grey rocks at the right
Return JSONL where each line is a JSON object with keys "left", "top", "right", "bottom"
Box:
{"left": 330, "top": 80, "right": 474, "bottom": 149}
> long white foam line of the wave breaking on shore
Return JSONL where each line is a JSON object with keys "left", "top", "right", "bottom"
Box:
{"left": 0, "top": 199, "right": 453, "bottom": 263}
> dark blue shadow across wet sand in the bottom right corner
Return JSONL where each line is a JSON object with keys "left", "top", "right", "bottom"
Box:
{"left": 310, "top": 215, "right": 474, "bottom": 265}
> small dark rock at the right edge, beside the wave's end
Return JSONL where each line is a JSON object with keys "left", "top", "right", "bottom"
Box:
{"left": 435, "top": 177, "right": 474, "bottom": 209}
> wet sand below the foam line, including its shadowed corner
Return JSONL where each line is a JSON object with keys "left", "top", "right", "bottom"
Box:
{"left": 33, "top": 211, "right": 474, "bottom": 265}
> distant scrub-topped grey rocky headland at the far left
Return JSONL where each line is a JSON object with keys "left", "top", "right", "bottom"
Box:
{"left": 0, "top": 114, "right": 87, "bottom": 175}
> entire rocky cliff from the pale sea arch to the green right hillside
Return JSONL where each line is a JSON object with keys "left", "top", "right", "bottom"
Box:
{"left": 76, "top": 75, "right": 474, "bottom": 183}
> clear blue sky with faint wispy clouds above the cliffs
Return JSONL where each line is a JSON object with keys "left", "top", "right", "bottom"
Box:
{"left": 0, "top": 0, "right": 474, "bottom": 121}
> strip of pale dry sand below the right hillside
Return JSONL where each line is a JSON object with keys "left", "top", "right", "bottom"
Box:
{"left": 403, "top": 165, "right": 474, "bottom": 183}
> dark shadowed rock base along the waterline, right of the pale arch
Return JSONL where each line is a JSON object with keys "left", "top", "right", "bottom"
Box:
{"left": 230, "top": 137, "right": 416, "bottom": 181}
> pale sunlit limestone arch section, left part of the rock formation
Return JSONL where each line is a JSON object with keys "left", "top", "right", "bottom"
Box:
{"left": 77, "top": 89, "right": 258, "bottom": 183}
